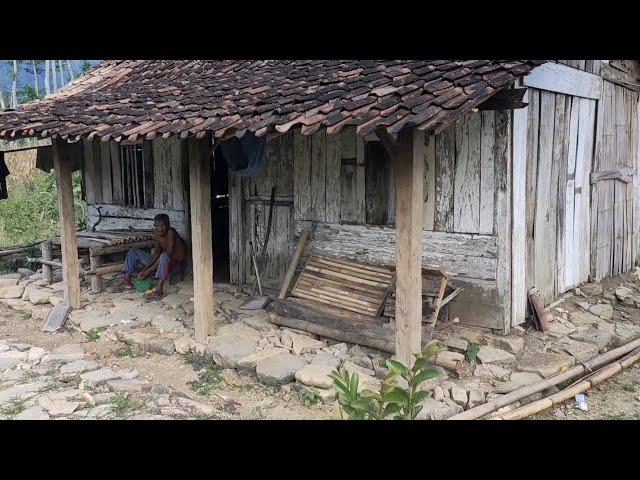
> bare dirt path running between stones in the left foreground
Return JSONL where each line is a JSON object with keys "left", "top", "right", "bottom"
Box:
{"left": 0, "top": 306, "right": 333, "bottom": 419}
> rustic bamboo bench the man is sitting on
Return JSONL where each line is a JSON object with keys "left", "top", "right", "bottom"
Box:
{"left": 40, "top": 230, "right": 155, "bottom": 293}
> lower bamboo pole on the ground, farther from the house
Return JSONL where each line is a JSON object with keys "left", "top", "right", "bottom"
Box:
{"left": 492, "top": 348, "right": 640, "bottom": 420}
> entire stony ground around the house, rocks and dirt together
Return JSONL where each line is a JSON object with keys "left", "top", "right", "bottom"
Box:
{"left": 0, "top": 271, "right": 640, "bottom": 419}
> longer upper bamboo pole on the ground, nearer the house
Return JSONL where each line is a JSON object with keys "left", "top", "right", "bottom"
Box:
{"left": 448, "top": 338, "right": 640, "bottom": 420}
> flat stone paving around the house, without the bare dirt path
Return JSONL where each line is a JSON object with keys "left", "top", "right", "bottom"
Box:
{"left": 0, "top": 266, "right": 640, "bottom": 419}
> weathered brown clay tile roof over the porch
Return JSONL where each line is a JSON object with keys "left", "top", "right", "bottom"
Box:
{"left": 0, "top": 60, "right": 543, "bottom": 141}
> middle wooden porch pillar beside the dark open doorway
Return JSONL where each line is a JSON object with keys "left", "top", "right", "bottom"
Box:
{"left": 188, "top": 136, "right": 213, "bottom": 342}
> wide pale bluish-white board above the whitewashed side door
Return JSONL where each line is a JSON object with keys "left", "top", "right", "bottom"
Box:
{"left": 522, "top": 63, "right": 602, "bottom": 100}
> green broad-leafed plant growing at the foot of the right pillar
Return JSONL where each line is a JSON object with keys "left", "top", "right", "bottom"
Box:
{"left": 329, "top": 343, "right": 442, "bottom": 420}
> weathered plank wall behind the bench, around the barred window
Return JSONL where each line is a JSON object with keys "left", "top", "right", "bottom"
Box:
{"left": 82, "top": 139, "right": 190, "bottom": 238}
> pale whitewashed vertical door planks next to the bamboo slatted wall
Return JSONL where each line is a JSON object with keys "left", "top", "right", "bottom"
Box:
{"left": 557, "top": 97, "right": 596, "bottom": 292}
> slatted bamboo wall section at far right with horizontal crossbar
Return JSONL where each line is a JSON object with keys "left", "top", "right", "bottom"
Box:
{"left": 591, "top": 80, "right": 640, "bottom": 280}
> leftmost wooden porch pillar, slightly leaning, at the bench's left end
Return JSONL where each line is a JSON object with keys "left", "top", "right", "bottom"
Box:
{"left": 52, "top": 139, "right": 80, "bottom": 308}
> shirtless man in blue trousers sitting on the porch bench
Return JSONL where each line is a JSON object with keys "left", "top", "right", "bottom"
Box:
{"left": 124, "top": 213, "right": 186, "bottom": 300}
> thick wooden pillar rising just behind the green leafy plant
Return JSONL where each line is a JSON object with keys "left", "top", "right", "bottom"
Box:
{"left": 395, "top": 128, "right": 425, "bottom": 366}
